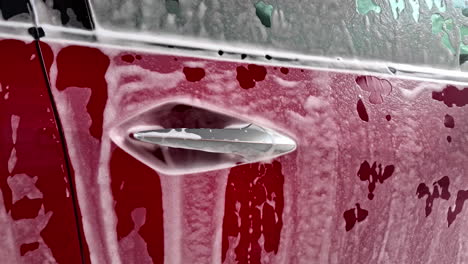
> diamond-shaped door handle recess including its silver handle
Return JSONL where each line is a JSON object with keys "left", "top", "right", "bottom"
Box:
{"left": 109, "top": 99, "right": 297, "bottom": 175}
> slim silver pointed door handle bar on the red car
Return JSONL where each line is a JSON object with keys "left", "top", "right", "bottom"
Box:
{"left": 131, "top": 124, "right": 296, "bottom": 160}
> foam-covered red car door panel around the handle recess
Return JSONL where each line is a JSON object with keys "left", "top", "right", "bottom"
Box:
{"left": 34, "top": 41, "right": 468, "bottom": 263}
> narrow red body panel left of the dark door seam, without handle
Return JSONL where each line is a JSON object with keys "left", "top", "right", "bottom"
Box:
{"left": 0, "top": 39, "right": 82, "bottom": 263}
